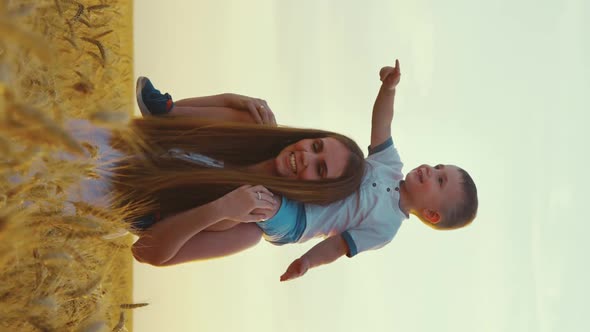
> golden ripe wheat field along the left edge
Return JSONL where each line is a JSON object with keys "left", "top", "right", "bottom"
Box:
{"left": 0, "top": 0, "right": 142, "bottom": 331}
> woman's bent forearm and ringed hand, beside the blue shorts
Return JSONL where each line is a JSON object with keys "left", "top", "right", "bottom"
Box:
{"left": 132, "top": 185, "right": 276, "bottom": 266}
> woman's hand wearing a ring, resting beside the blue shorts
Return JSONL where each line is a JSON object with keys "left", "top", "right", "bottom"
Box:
{"left": 219, "top": 185, "right": 277, "bottom": 222}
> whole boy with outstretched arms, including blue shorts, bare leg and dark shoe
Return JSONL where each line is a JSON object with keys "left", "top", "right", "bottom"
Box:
{"left": 137, "top": 60, "right": 478, "bottom": 281}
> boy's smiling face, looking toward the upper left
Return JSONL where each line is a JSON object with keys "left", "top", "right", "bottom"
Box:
{"left": 403, "top": 164, "right": 463, "bottom": 223}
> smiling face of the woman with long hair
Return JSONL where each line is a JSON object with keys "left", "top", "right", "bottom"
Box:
{"left": 275, "top": 137, "right": 351, "bottom": 181}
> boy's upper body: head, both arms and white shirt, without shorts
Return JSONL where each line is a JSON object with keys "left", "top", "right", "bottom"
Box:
{"left": 281, "top": 60, "right": 478, "bottom": 281}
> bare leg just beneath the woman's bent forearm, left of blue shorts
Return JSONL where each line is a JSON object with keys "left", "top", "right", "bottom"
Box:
{"left": 165, "top": 223, "right": 262, "bottom": 265}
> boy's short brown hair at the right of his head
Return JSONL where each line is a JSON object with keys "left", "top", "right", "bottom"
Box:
{"left": 431, "top": 168, "right": 478, "bottom": 230}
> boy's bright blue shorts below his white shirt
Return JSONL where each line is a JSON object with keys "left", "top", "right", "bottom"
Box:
{"left": 256, "top": 197, "right": 307, "bottom": 246}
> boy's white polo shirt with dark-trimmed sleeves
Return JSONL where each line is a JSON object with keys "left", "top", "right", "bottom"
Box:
{"left": 298, "top": 138, "right": 409, "bottom": 257}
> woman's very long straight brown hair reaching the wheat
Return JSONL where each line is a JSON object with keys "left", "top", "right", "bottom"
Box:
{"left": 112, "top": 117, "right": 364, "bottom": 218}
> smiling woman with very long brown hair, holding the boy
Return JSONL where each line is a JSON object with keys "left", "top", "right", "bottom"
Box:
{"left": 106, "top": 85, "right": 364, "bottom": 266}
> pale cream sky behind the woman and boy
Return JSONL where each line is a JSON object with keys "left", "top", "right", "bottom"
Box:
{"left": 134, "top": 0, "right": 590, "bottom": 332}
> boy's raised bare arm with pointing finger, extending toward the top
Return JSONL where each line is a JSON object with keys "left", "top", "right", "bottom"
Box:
{"left": 371, "top": 60, "right": 401, "bottom": 148}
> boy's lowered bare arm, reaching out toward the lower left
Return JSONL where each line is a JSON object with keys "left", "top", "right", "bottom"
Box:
{"left": 281, "top": 235, "right": 348, "bottom": 281}
